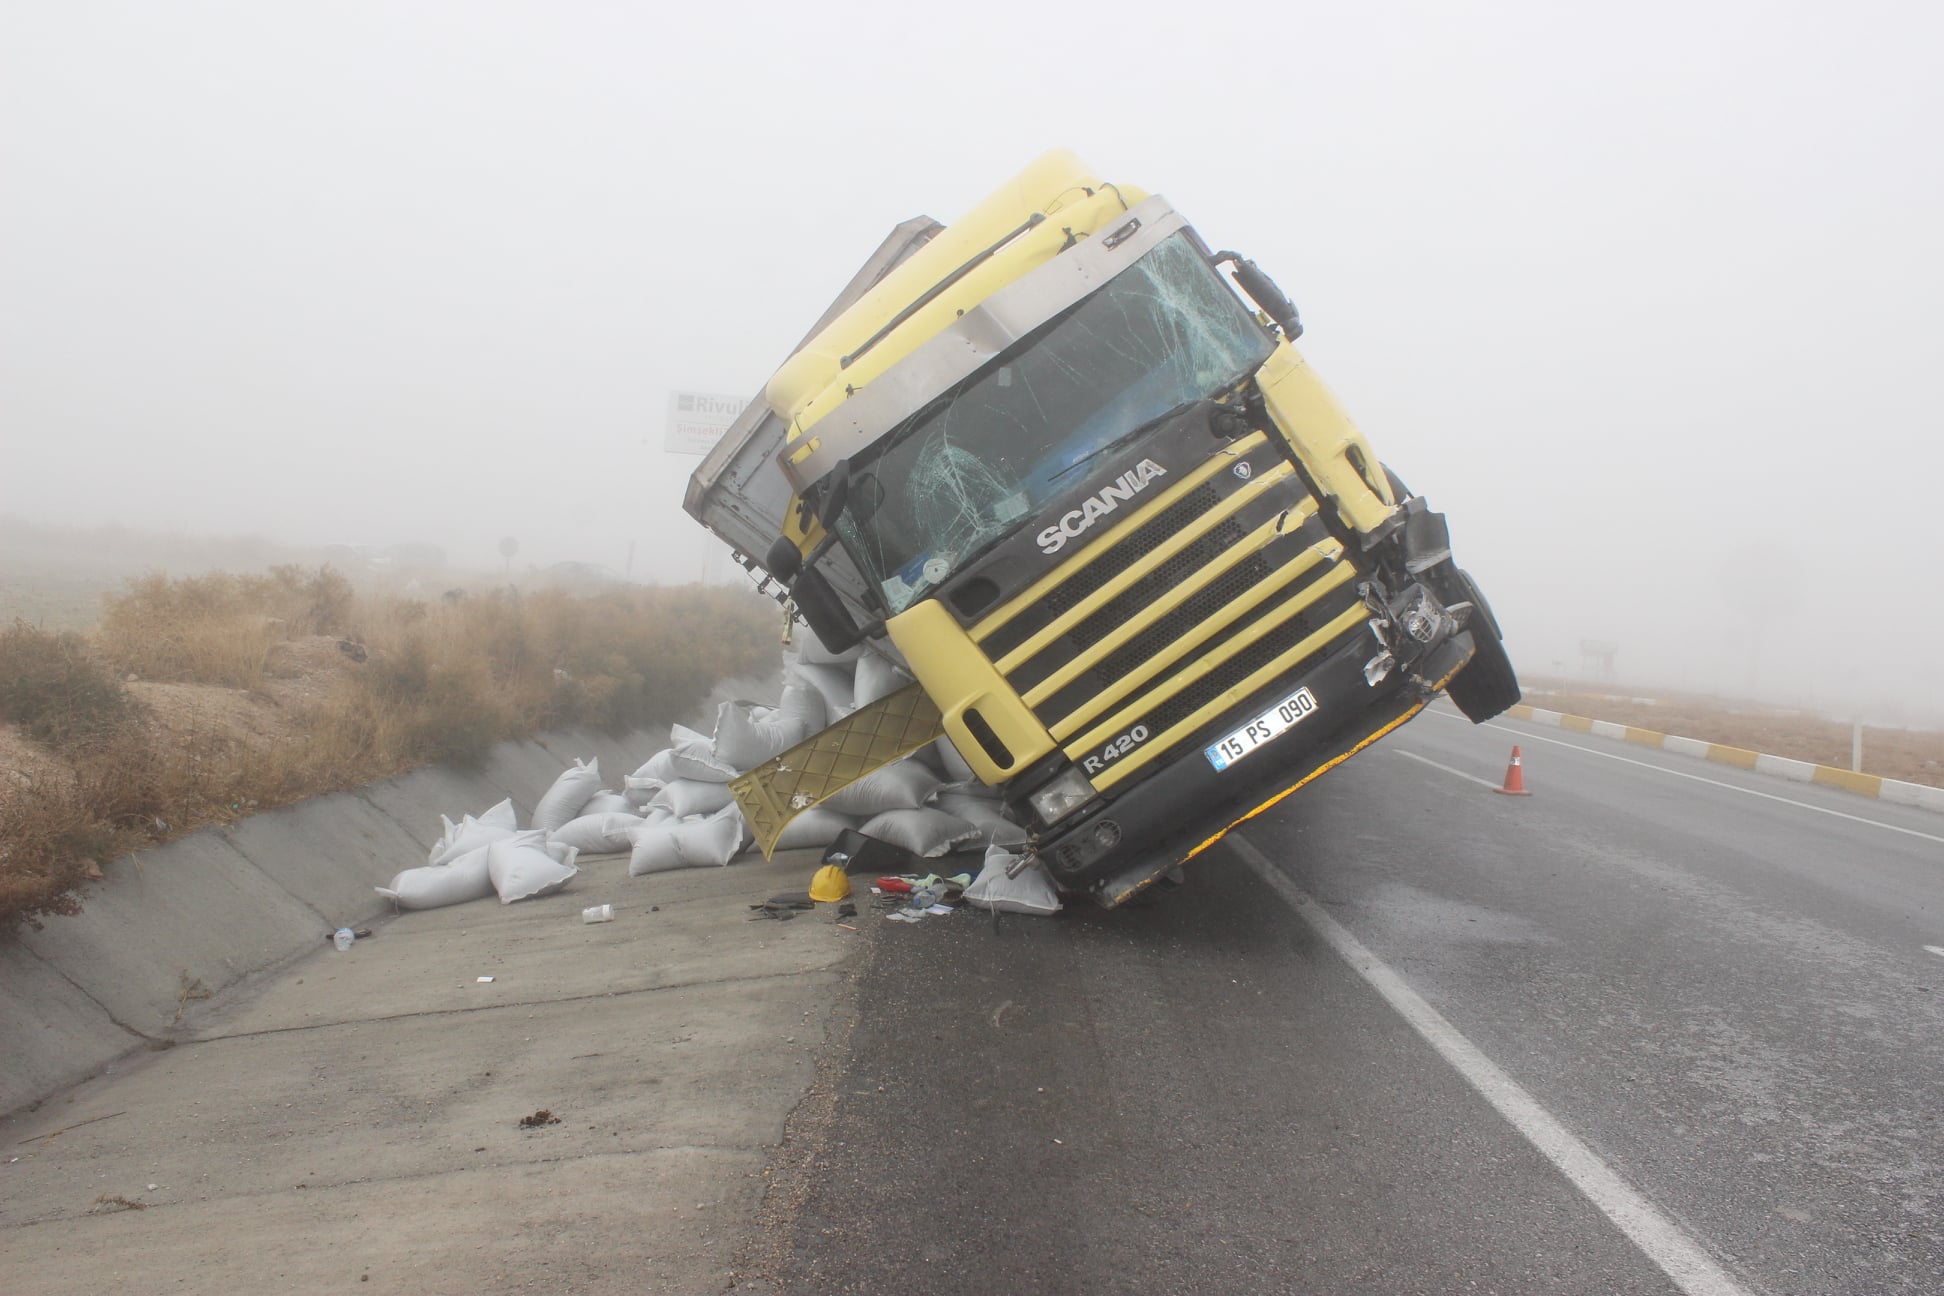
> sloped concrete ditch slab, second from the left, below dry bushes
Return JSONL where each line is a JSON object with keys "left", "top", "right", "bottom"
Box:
{"left": 19, "top": 828, "right": 327, "bottom": 1036}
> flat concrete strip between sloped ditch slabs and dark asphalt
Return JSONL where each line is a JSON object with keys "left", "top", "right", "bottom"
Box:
{"left": 0, "top": 851, "right": 855, "bottom": 1292}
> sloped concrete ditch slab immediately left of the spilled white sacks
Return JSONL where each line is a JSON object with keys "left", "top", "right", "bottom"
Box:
{"left": 220, "top": 793, "right": 435, "bottom": 927}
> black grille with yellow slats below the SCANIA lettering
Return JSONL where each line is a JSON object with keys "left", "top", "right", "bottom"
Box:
{"left": 972, "top": 446, "right": 1363, "bottom": 787}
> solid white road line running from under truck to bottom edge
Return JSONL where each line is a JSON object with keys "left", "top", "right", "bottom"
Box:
{"left": 1229, "top": 834, "right": 1748, "bottom": 1296}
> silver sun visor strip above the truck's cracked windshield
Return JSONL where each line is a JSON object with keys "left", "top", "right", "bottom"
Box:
{"left": 778, "top": 196, "right": 1188, "bottom": 494}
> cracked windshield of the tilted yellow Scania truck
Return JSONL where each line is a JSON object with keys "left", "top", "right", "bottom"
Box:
{"left": 838, "top": 233, "right": 1271, "bottom": 612}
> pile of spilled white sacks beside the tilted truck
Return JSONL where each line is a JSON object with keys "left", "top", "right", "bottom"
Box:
{"left": 379, "top": 633, "right": 1049, "bottom": 909}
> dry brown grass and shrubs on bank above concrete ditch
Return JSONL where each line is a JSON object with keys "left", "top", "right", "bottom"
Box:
{"left": 0, "top": 567, "right": 778, "bottom": 931}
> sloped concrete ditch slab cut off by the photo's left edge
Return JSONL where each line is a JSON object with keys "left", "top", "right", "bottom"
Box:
{"left": 0, "top": 940, "right": 142, "bottom": 1119}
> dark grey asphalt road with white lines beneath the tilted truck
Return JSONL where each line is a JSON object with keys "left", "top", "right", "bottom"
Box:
{"left": 745, "top": 713, "right": 1944, "bottom": 1294}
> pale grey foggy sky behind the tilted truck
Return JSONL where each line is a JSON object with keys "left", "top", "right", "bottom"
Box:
{"left": 0, "top": 0, "right": 1944, "bottom": 719}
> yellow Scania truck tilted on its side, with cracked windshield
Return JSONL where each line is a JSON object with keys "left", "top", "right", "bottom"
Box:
{"left": 684, "top": 150, "right": 1520, "bottom": 907}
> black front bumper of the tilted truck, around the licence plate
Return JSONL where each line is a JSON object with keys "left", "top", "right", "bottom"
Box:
{"left": 1038, "top": 631, "right": 1474, "bottom": 907}
